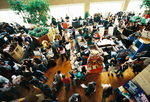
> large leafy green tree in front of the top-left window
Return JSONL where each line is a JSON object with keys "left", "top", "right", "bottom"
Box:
{"left": 7, "top": 0, "right": 50, "bottom": 25}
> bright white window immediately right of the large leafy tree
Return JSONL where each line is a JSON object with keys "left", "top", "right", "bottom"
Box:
{"left": 50, "top": 3, "right": 84, "bottom": 20}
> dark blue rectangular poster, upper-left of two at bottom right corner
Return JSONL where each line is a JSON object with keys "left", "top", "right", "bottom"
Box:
{"left": 123, "top": 80, "right": 142, "bottom": 95}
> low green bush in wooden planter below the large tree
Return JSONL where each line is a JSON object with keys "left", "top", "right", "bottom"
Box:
{"left": 29, "top": 27, "right": 49, "bottom": 37}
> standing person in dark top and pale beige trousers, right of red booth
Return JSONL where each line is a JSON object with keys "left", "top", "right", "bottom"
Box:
{"left": 108, "top": 57, "right": 117, "bottom": 76}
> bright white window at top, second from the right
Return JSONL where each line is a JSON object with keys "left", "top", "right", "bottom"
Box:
{"left": 89, "top": 1, "right": 124, "bottom": 18}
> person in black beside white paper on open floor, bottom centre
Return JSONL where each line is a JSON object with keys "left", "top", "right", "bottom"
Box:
{"left": 84, "top": 81, "right": 96, "bottom": 95}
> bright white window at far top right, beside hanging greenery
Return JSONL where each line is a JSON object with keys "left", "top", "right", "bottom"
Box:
{"left": 126, "top": 0, "right": 145, "bottom": 15}
